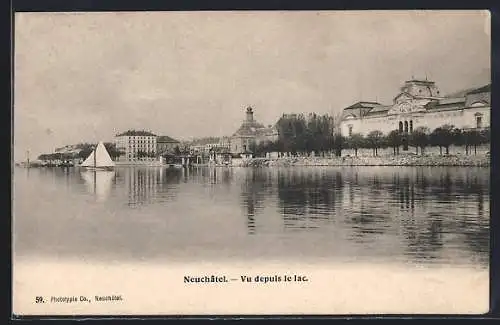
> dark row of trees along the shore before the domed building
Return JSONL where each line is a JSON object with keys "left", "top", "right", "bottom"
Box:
{"left": 251, "top": 122, "right": 490, "bottom": 156}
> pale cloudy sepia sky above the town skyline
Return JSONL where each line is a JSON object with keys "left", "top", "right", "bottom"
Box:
{"left": 13, "top": 11, "right": 491, "bottom": 161}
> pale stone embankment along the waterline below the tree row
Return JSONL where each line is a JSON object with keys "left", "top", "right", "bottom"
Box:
{"left": 240, "top": 155, "right": 490, "bottom": 167}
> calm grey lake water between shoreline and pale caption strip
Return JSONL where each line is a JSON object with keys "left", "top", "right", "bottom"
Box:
{"left": 13, "top": 167, "right": 490, "bottom": 269}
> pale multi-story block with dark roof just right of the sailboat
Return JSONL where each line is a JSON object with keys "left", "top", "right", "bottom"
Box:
{"left": 115, "top": 130, "right": 157, "bottom": 161}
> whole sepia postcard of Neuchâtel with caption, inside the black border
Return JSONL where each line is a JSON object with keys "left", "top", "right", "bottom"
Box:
{"left": 11, "top": 10, "right": 491, "bottom": 316}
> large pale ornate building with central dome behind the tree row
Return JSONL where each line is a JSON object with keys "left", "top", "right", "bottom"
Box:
{"left": 340, "top": 80, "right": 491, "bottom": 137}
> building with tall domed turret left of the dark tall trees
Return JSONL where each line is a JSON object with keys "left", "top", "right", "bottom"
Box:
{"left": 230, "top": 107, "right": 278, "bottom": 154}
